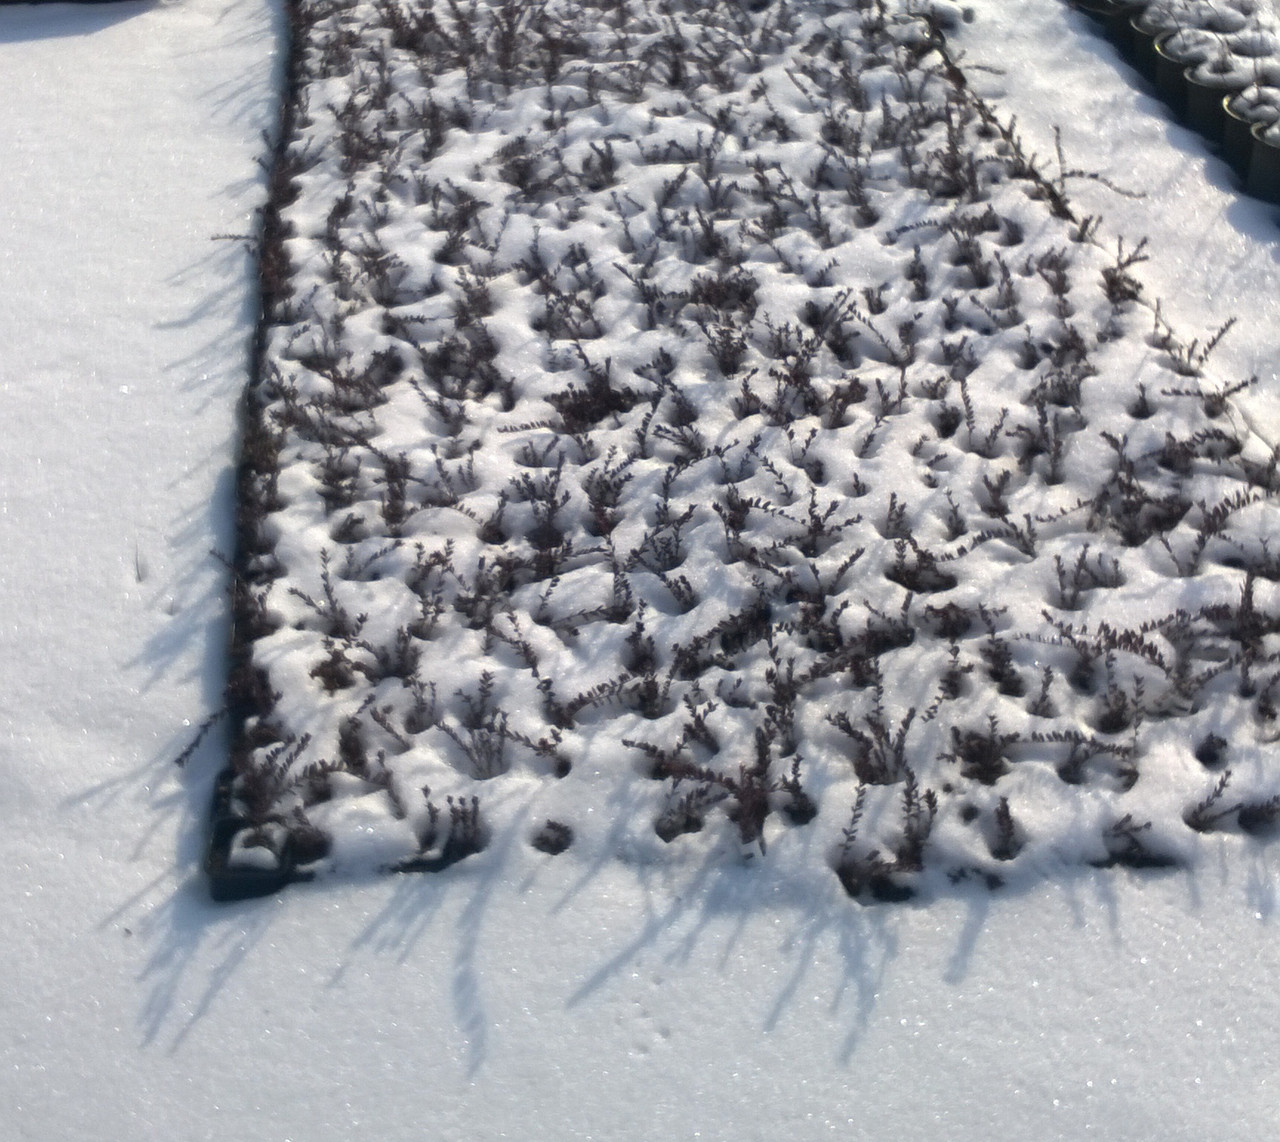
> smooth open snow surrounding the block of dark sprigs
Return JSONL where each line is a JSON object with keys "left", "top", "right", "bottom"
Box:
{"left": 0, "top": 0, "right": 1280, "bottom": 1139}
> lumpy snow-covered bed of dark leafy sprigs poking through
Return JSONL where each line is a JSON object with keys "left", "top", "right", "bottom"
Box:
{"left": 234, "top": 5, "right": 1276, "bottom": 896}
